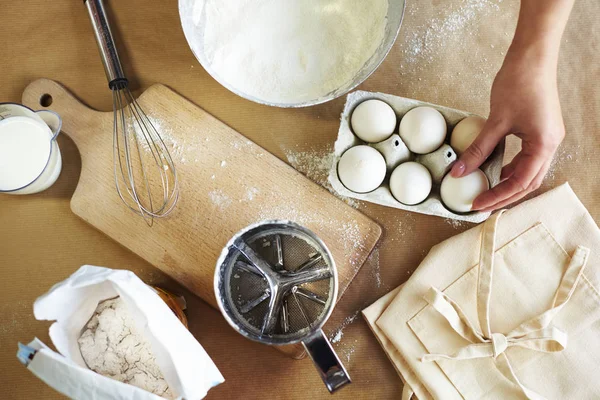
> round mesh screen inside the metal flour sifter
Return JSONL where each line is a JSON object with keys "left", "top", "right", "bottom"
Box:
{"left": 225, "top": 229, "right": 335, "bottom": 342}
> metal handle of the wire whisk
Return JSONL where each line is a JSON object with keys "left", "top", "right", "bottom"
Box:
{"left": 84, "top": 0, "right": 127, "bottom": 90}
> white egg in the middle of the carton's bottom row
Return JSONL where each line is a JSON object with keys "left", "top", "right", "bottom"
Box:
{"left": 390, "top": 161, "right": 431, "bottom": 206}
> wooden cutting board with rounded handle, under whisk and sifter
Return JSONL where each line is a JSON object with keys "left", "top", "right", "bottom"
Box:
{"left": 23, "top": 79, "right": 381, "bottom": 357}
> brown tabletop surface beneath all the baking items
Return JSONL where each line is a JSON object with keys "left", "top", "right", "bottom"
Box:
{"left": 0, "top": 0, "right": 600, "bottom": 399}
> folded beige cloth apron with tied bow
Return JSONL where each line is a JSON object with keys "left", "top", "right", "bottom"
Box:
{"left": 363, "top": 184, "right": 600, "bottom": 400}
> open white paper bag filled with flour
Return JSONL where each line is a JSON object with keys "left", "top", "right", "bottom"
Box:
{"left": 18, "top": 265, "right": 224, "bottom": 400}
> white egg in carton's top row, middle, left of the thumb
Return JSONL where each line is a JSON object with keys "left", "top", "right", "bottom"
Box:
{"left": 399, "top": 107, "right": 446, "bottom": 154}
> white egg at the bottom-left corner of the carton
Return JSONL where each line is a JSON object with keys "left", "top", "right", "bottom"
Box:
{"left": 338, "top": 146, "right": 386, "bottom": 193}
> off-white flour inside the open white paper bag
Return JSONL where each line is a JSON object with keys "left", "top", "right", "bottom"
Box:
{"left": 77, "top": 297, "right": 175, "bottom": 399}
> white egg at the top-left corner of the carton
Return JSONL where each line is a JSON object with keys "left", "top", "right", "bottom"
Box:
{"left": 350, "top": 100, "right": 396, "bottom": 143}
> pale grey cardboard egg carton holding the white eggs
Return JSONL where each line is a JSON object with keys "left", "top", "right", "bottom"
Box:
{"left": 329, "top": 91, "right": 504, "bottom": 223}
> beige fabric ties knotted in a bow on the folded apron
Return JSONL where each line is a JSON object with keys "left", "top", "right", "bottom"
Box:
{"left": 421, "top": 211, "right": 589, "bottom": 400}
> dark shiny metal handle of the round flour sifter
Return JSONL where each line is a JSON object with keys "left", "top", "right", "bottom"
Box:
{"left": 302, "top": 329, "right": 352, "bottom": 393}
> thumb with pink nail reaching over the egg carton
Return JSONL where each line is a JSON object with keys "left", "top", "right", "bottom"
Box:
{"left": 451, "top": 119, "right": 506, "bottom": 178}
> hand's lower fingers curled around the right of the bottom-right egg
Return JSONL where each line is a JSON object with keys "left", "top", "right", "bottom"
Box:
{"left": 473, "top": 152, "right": 547, "bottom": 210}
